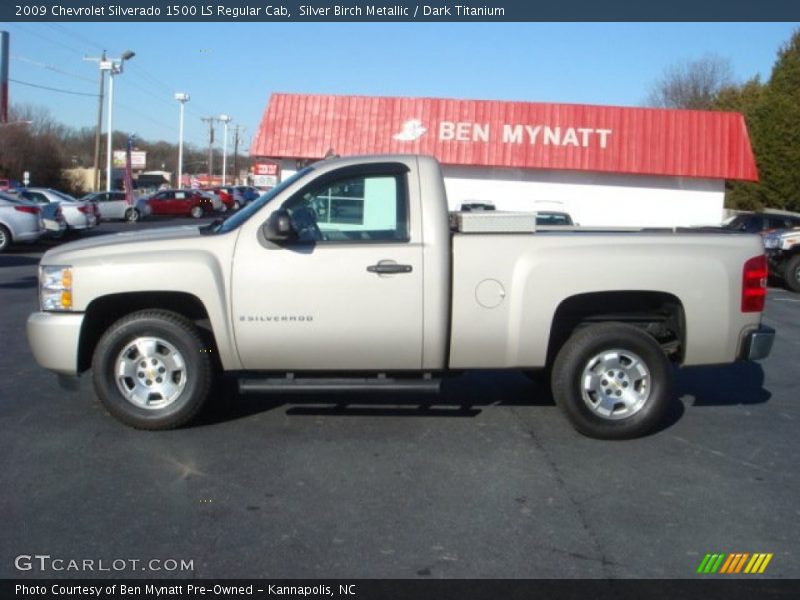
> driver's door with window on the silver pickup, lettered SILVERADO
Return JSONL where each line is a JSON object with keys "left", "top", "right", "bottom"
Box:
{"left": 232, "top": 163, "right": 423, "bottom": 371}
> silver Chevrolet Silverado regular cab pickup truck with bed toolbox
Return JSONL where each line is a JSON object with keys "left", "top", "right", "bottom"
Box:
{"left": 27, "top": 155, "right": 775, "bottom": 439}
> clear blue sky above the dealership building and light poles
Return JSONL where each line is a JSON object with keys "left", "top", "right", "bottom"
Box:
{"left": 0, "top": 22, "right": 800, "bottom": 156}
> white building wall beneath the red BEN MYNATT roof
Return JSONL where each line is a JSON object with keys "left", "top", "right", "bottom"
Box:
{"left": 280, "top": 159, "right": 725, "bottom": 227}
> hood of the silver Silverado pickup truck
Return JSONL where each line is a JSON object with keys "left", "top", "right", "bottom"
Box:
{"left": 41, "top": 225, "right": 204, "bottom": 265}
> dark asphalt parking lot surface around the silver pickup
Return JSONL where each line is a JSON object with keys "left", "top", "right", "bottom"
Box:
{"left": 0, "top": 220, "right": 800, "bottom": 579}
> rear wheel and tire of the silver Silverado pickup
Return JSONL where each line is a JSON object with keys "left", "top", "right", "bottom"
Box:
{"left": 552, "top": 323, "right": 672, "bottom": 440}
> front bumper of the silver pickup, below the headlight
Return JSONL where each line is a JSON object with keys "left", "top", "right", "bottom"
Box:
{"left": 27, "top": 312, "right": 84, "bottom": 375}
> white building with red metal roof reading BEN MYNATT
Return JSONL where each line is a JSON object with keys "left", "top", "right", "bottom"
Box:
{"left": 250, "top": 94, "right": 758, "bottom": 226}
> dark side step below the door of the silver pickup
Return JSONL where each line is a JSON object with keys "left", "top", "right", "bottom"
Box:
{"left": 239, "top": 373, "right": 442, "bottom": 394}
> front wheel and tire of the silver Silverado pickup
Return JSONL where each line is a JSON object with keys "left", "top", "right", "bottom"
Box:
{"left": 92, "top": 310, "right": 214, "bottom": 430}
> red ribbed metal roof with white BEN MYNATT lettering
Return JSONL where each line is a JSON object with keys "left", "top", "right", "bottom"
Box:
{"left": 250, "top": 94, "right": 758, "bottom": 181}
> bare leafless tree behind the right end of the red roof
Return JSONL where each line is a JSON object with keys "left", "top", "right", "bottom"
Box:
{"left": 647, "top": 54, "right": 733, "bottom": 110}
